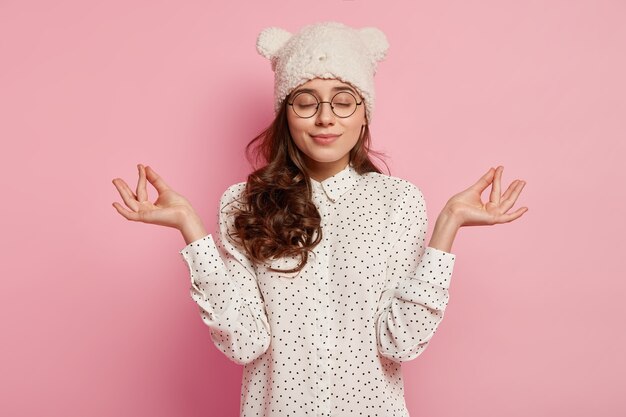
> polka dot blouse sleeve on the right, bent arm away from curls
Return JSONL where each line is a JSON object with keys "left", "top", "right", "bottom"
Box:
{"left": 376, "top": 187, "right": 456, "bottom": 362}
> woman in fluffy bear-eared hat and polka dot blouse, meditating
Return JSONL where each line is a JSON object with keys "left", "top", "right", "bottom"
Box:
{"left": 113, "top": 22, "right": 527, "bottom": 417}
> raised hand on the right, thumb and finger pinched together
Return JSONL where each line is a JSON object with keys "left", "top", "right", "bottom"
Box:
{"left": 443, "top": 165, "right": 528, "bottom": 226}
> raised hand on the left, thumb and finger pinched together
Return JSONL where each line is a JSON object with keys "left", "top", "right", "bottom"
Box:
{"left": 113, "top": 164, "right": 199, "bottom": 231}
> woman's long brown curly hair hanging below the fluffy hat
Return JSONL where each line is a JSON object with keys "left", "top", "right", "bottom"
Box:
{"left": 229, "top": 96, "right": 389, "bottom": 272}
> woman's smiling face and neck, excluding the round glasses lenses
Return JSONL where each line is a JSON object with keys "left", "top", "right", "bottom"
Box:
{"left": 287, "top": 78, "right": 367, "bottom": 181}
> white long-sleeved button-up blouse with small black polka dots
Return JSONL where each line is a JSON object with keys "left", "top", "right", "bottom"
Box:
{"left": 180, "top": 164, "right": 455, "bottom": 417}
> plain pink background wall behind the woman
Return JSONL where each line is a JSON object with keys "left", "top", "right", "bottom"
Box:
{"left": 0, "top": 0, "right": 626, "bottom": 417}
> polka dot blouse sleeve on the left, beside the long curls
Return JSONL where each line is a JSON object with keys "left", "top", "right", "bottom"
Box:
{"left": 179, "top": 183, "right": 271, "bottom": 364}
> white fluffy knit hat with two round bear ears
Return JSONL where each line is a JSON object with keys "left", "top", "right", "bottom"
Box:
{"left": 256, "top": 22, "right": 389, "bottom": 122}
